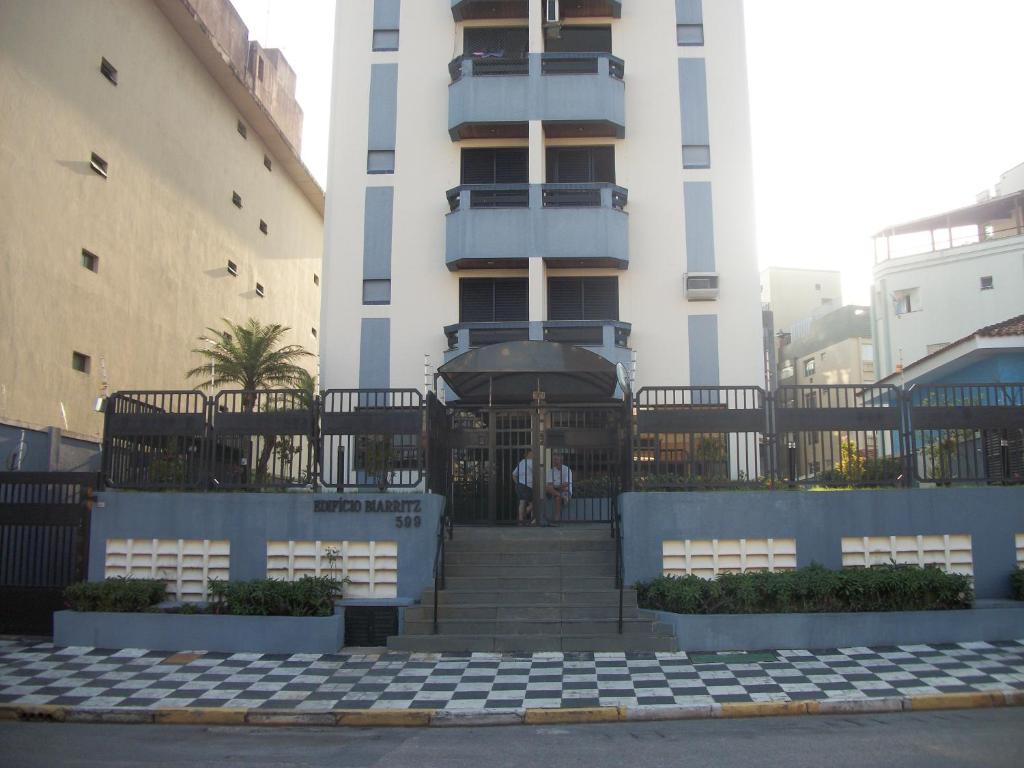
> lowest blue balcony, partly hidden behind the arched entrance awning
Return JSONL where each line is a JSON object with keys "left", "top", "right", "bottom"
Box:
{"left": 444, "top": 321, "right": 633, "bottom": 366}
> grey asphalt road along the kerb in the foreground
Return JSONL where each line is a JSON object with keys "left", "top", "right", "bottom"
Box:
{"left": 0, "top": 709, "right": 1024, "bottom": 768}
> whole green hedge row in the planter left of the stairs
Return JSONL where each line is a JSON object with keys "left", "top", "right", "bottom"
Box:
{"left": 65, "top": 577, "right": 342, "bottom": 616}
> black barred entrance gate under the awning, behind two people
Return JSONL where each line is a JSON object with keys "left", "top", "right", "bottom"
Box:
{"left": 442, "top": 403, "right": 628, "bottom": 525}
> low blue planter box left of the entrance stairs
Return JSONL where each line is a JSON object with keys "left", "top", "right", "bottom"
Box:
{"left": 53, "top": 609, "right": 345, "bottom": 653}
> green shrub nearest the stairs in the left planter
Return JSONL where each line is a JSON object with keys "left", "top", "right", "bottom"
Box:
{"left": 210, "top": 577, "right": 342, "bottom": 616}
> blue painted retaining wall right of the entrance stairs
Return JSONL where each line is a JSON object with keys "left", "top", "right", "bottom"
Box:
{"left": 620, "top": 487, "right": 1024, "bottom": 599}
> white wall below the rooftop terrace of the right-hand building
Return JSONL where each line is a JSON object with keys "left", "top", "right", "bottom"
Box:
{"left": 872, "top": 237, "right": 1024, "bottom": 378}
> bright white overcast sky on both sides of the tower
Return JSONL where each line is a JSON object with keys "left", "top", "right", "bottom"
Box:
{"left": 232, "top": 0, "right": 1024, "bottom": 303}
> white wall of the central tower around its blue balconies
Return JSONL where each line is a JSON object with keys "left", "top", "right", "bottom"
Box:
{"left": 321, "top": 0, "right": 763, "bottom": 387}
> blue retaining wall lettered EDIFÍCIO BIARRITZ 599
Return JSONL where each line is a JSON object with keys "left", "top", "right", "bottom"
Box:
{"left": 89, "top": 490, "right": 444, "bottom": 605}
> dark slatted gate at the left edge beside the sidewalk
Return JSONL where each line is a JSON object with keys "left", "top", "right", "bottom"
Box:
{"left": 0, "top": 472, "right": 97, "bottom": 635}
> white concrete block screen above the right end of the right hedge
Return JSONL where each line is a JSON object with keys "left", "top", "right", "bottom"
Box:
{"left": 843, "top": 534, "right": 974, "bottom": 575}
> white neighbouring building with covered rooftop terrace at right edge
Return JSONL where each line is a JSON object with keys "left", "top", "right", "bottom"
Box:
{"left": 871, "top": 166, "right": 1024, "bottom": 377}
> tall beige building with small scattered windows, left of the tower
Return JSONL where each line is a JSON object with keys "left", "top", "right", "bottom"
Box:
{"left": 0, "top": 0, "right": 324, "bottom": 469}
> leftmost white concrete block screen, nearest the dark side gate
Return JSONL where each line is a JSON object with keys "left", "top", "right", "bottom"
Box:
{"left": 103, "top": 539, "right": 231, "bottom": 602}
